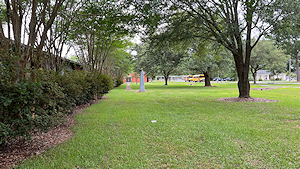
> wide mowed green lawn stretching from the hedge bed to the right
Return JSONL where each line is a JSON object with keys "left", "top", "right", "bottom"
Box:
{"left": 17, "top": 82, "right": 300, "bottom": 168}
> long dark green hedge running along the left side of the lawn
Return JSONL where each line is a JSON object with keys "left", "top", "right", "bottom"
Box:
{"left": 0, "top": 62, "right": 120, "bottom": 145}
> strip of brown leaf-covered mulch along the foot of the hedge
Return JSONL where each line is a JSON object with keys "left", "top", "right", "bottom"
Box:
{"left": 0, "top": 96, "right": 102, "bottom": 168}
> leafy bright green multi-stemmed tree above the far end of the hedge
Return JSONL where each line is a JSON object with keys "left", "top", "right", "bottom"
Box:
{"left": 69, "top": 0, "right": 132, "bottom": 74}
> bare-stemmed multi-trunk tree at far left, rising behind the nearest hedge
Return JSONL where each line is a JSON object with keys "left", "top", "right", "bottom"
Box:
{"left": 0, "top": 0, "right": 74, "bottom": 75}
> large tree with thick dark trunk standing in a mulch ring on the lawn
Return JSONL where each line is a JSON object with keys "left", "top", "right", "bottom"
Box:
{"left": 135, "top": 0, "right": 281, "bottom": 98}
